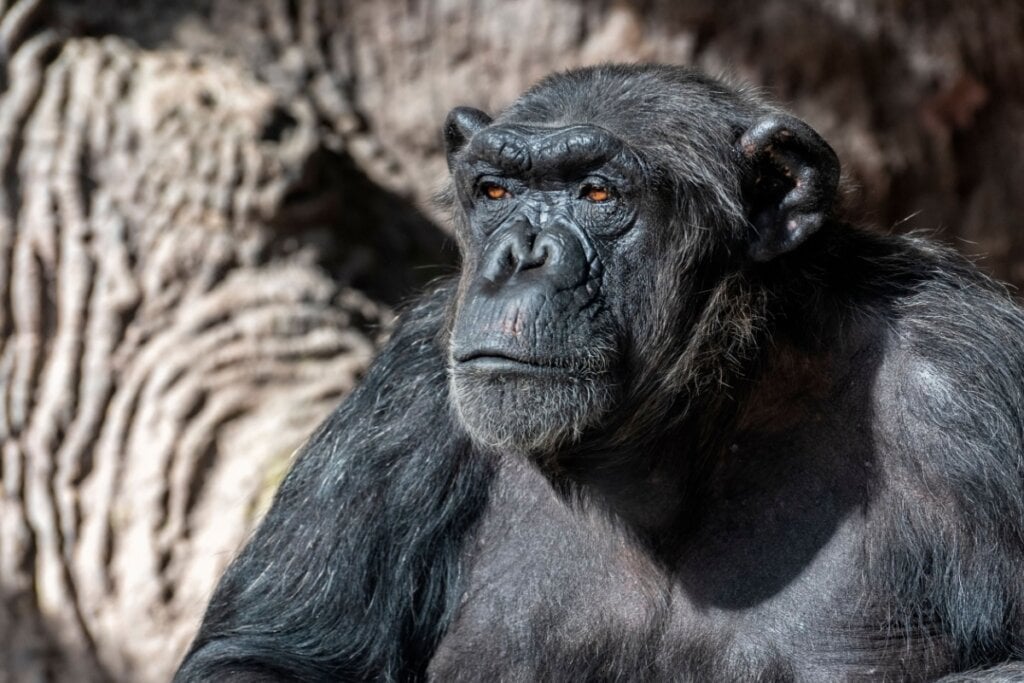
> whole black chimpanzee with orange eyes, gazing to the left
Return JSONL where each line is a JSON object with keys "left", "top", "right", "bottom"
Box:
{"left": 178, "top": 66, "right": 1024, "bottom": 681}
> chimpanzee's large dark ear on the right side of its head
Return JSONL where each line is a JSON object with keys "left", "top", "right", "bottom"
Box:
{"left": 738, "top": 114, "right": 839, "bottom": 262}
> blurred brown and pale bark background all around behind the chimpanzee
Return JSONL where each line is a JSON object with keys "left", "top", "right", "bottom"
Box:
{"left": 0, "top": 0, "right": 1024, "bottom": 683}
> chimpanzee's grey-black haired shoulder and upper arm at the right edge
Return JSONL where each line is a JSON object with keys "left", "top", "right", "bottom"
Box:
{"left": 871, "top": 240, "right": 1024, "bottom": 668}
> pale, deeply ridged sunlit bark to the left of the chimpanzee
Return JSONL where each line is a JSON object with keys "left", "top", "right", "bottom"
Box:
{"left": 0, "top": 3, "right": 393, "bottom": 681}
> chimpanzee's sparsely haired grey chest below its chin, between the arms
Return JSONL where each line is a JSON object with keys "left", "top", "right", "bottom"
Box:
{"left": 429, "top": 450, "right": 948, "bottom": 681}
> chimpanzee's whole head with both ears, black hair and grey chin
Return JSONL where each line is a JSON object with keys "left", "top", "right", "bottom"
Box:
{"left": 444, "top": 66, "right": 839, "bottom": 456}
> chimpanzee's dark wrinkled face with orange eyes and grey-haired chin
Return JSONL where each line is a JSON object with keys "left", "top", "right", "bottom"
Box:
{"left": 447, "top": 109, "right": 643, "bottom": 452}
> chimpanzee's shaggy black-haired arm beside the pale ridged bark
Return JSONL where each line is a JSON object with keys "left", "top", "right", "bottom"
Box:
{"left": 175, "top": 280, "right": 490, "bottom": 682}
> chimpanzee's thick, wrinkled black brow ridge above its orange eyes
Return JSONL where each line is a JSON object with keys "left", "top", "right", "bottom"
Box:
{"left": 465, "top": 124, "right": 637, "bottom": 177}
